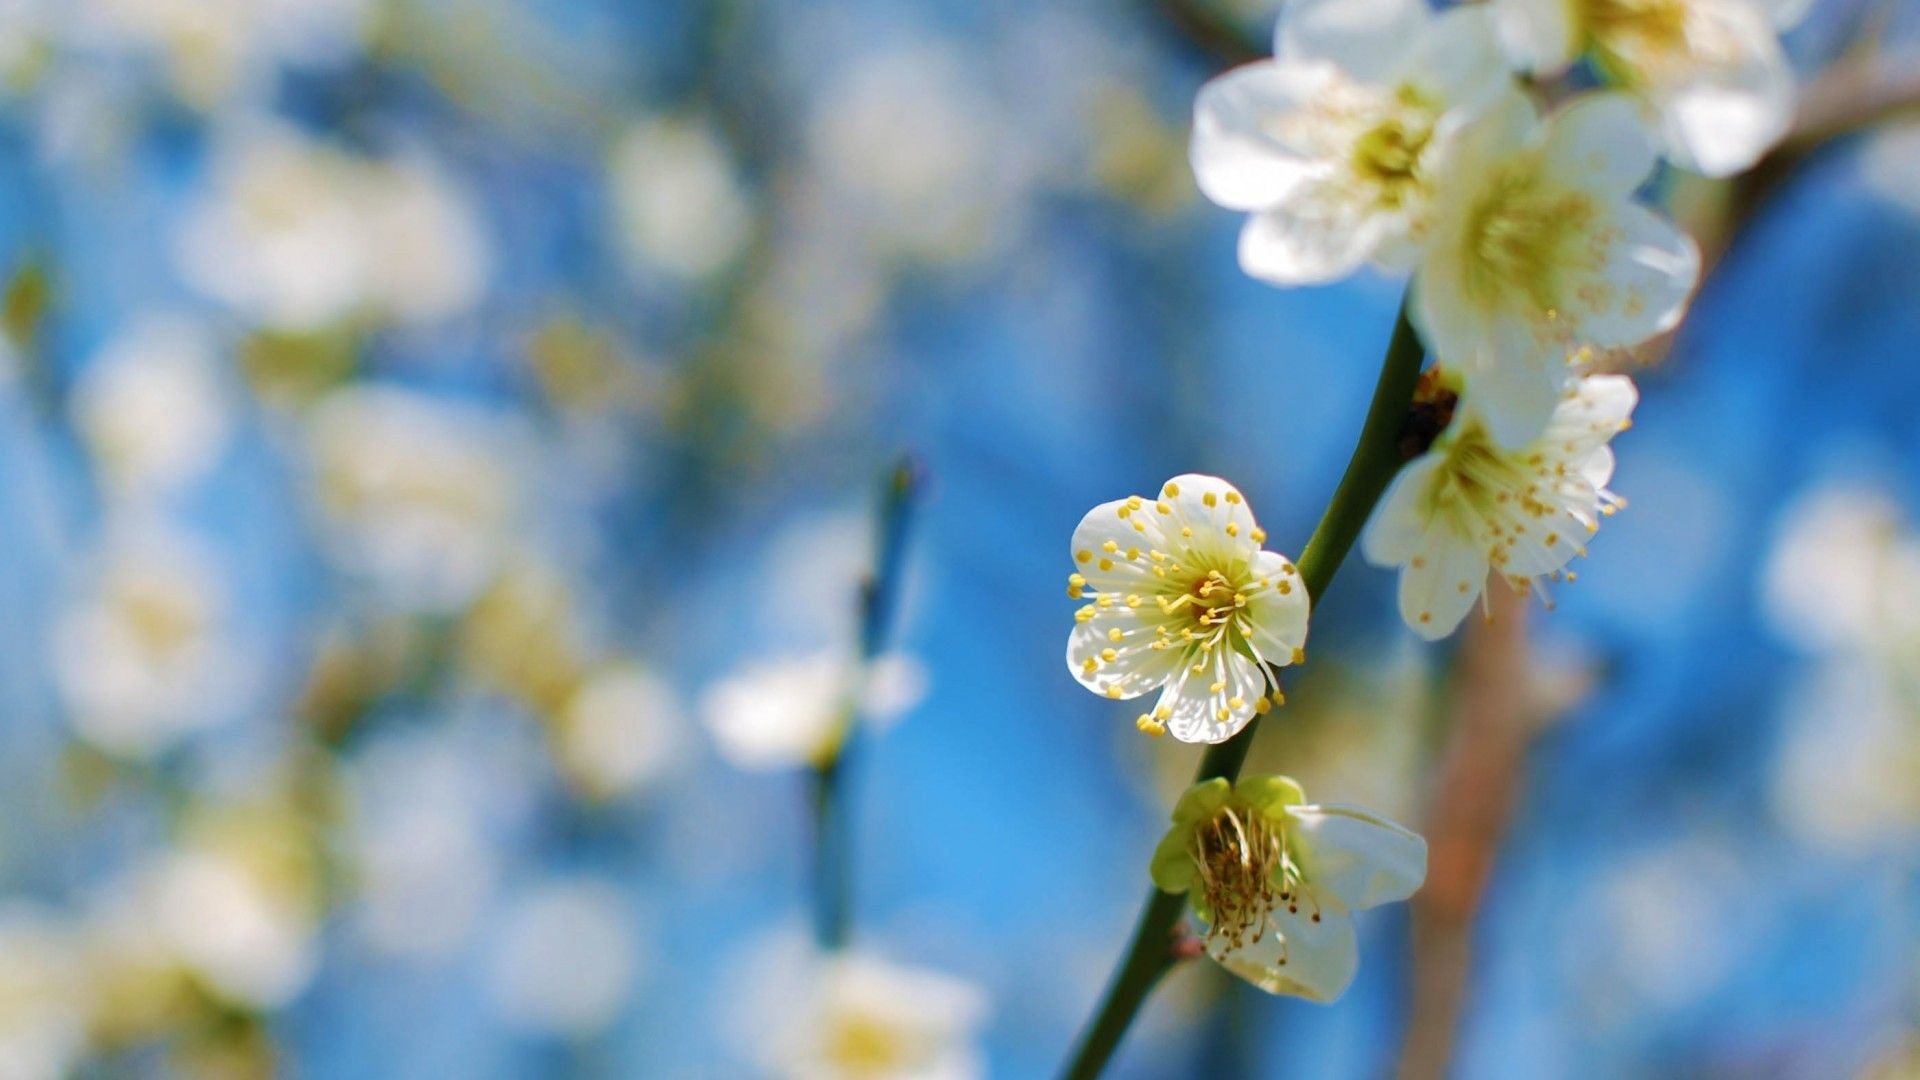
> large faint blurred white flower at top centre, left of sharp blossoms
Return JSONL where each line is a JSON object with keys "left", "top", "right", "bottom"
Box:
{"left": 806, "top": 46, "right": 1027, "bottom": 259}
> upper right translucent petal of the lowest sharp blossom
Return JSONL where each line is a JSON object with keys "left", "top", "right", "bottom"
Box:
{"left": 1286, "top": 805, "right": 1427, "bottom": 911}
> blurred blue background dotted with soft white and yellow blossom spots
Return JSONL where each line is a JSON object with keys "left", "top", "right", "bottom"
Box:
{"left": 0, "top": 0, "right": 1920, "bottom": 1078}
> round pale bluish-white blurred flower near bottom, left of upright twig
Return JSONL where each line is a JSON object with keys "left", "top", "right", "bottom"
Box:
{"left": 488, "top": 880, "right": 641, "bottom": 1036}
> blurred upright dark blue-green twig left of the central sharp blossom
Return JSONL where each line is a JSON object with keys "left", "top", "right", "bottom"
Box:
{"left": 814, "top": 455, "right": 925, "bottom": 949}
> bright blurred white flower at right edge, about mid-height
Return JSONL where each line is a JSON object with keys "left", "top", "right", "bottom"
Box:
{"left": 1763, "top": 486, "right": 1920, "bottom": 651}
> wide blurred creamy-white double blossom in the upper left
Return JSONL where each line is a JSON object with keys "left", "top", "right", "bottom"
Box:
{"left": 179, "top": 123, "right": 492, "bottom": 331}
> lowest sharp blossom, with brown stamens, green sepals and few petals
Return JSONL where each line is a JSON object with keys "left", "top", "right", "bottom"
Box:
{"left": 1152, "top": 776, "right": 1427, "bottom": 1003}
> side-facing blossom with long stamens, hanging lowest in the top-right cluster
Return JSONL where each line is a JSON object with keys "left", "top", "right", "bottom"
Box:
{"left": 1361, "top": 375, "right": 1638, "bottom": 640}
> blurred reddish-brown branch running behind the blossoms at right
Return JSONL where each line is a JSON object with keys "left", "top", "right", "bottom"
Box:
{"left": 1400, "top": 42, "right": 1920, "bottom": 1080}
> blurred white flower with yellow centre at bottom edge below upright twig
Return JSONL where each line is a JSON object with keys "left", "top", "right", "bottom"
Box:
{"left": 743, "top": 951, "right": 987, "bottom": 1080}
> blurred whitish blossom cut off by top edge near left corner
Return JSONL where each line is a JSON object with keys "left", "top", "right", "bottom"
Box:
{"left": 61, "top": 0, "right": 374, "bottom": 108}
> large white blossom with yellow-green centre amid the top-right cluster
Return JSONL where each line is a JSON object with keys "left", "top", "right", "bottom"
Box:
{"left": 1411, "top": 94, "right": 1699, "bottom": 446}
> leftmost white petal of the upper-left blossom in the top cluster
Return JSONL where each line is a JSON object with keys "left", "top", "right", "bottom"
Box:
{"left": 1190, "top": 60, "right": 1327, "bottom": 209}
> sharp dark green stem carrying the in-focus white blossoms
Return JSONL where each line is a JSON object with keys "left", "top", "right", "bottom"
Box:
{"left": 1064, "top": 295, "right": 1425, "bottom": 1080}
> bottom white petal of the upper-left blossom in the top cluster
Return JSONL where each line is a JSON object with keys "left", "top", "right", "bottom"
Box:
{"left": 1240, "top": 181, "right": 1390, "bottom": 284}
